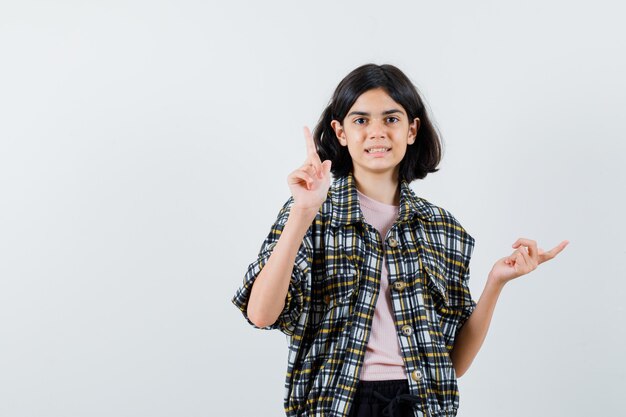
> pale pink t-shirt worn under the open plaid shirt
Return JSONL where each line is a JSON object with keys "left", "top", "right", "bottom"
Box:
{"left": 357, "top": 190, "right": 407, "bottom": 381}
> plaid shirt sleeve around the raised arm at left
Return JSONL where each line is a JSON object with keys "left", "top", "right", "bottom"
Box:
{"left": 231, "top": 197, "right": 312, "bottom": 335}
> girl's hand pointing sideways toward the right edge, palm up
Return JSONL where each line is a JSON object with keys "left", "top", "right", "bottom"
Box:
{"left": 489, "top": 238, "right": 569, "bottom": 285}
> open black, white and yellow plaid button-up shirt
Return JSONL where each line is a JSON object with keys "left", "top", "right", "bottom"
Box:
{"left": 232, "top": 173, "right": 476, "bottom": 417}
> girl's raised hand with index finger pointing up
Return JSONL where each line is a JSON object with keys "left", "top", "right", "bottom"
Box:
{"left": 287, "top": 126, "right": 331, "bottom": 210}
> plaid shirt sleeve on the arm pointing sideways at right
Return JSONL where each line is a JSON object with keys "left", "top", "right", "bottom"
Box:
{"left": 442, "top": 232, "right": 476, "bottom": 351}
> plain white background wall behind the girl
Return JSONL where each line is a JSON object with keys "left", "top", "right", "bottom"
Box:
{"left": 0, "top": 0, "right": 626, "bottom": 417}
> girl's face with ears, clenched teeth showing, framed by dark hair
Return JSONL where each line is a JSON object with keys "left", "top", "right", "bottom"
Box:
{"left": 331, "top": 88, "right": 419, "bottom": 179}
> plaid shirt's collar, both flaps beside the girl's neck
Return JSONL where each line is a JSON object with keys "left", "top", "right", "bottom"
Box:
{"left": 330, "top": 172, "right": 433, "bottom": 227}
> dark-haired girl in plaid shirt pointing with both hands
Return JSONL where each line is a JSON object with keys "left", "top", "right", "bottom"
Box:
{"left": 232, "top": 64, "right": 568, "bottom": 417}
